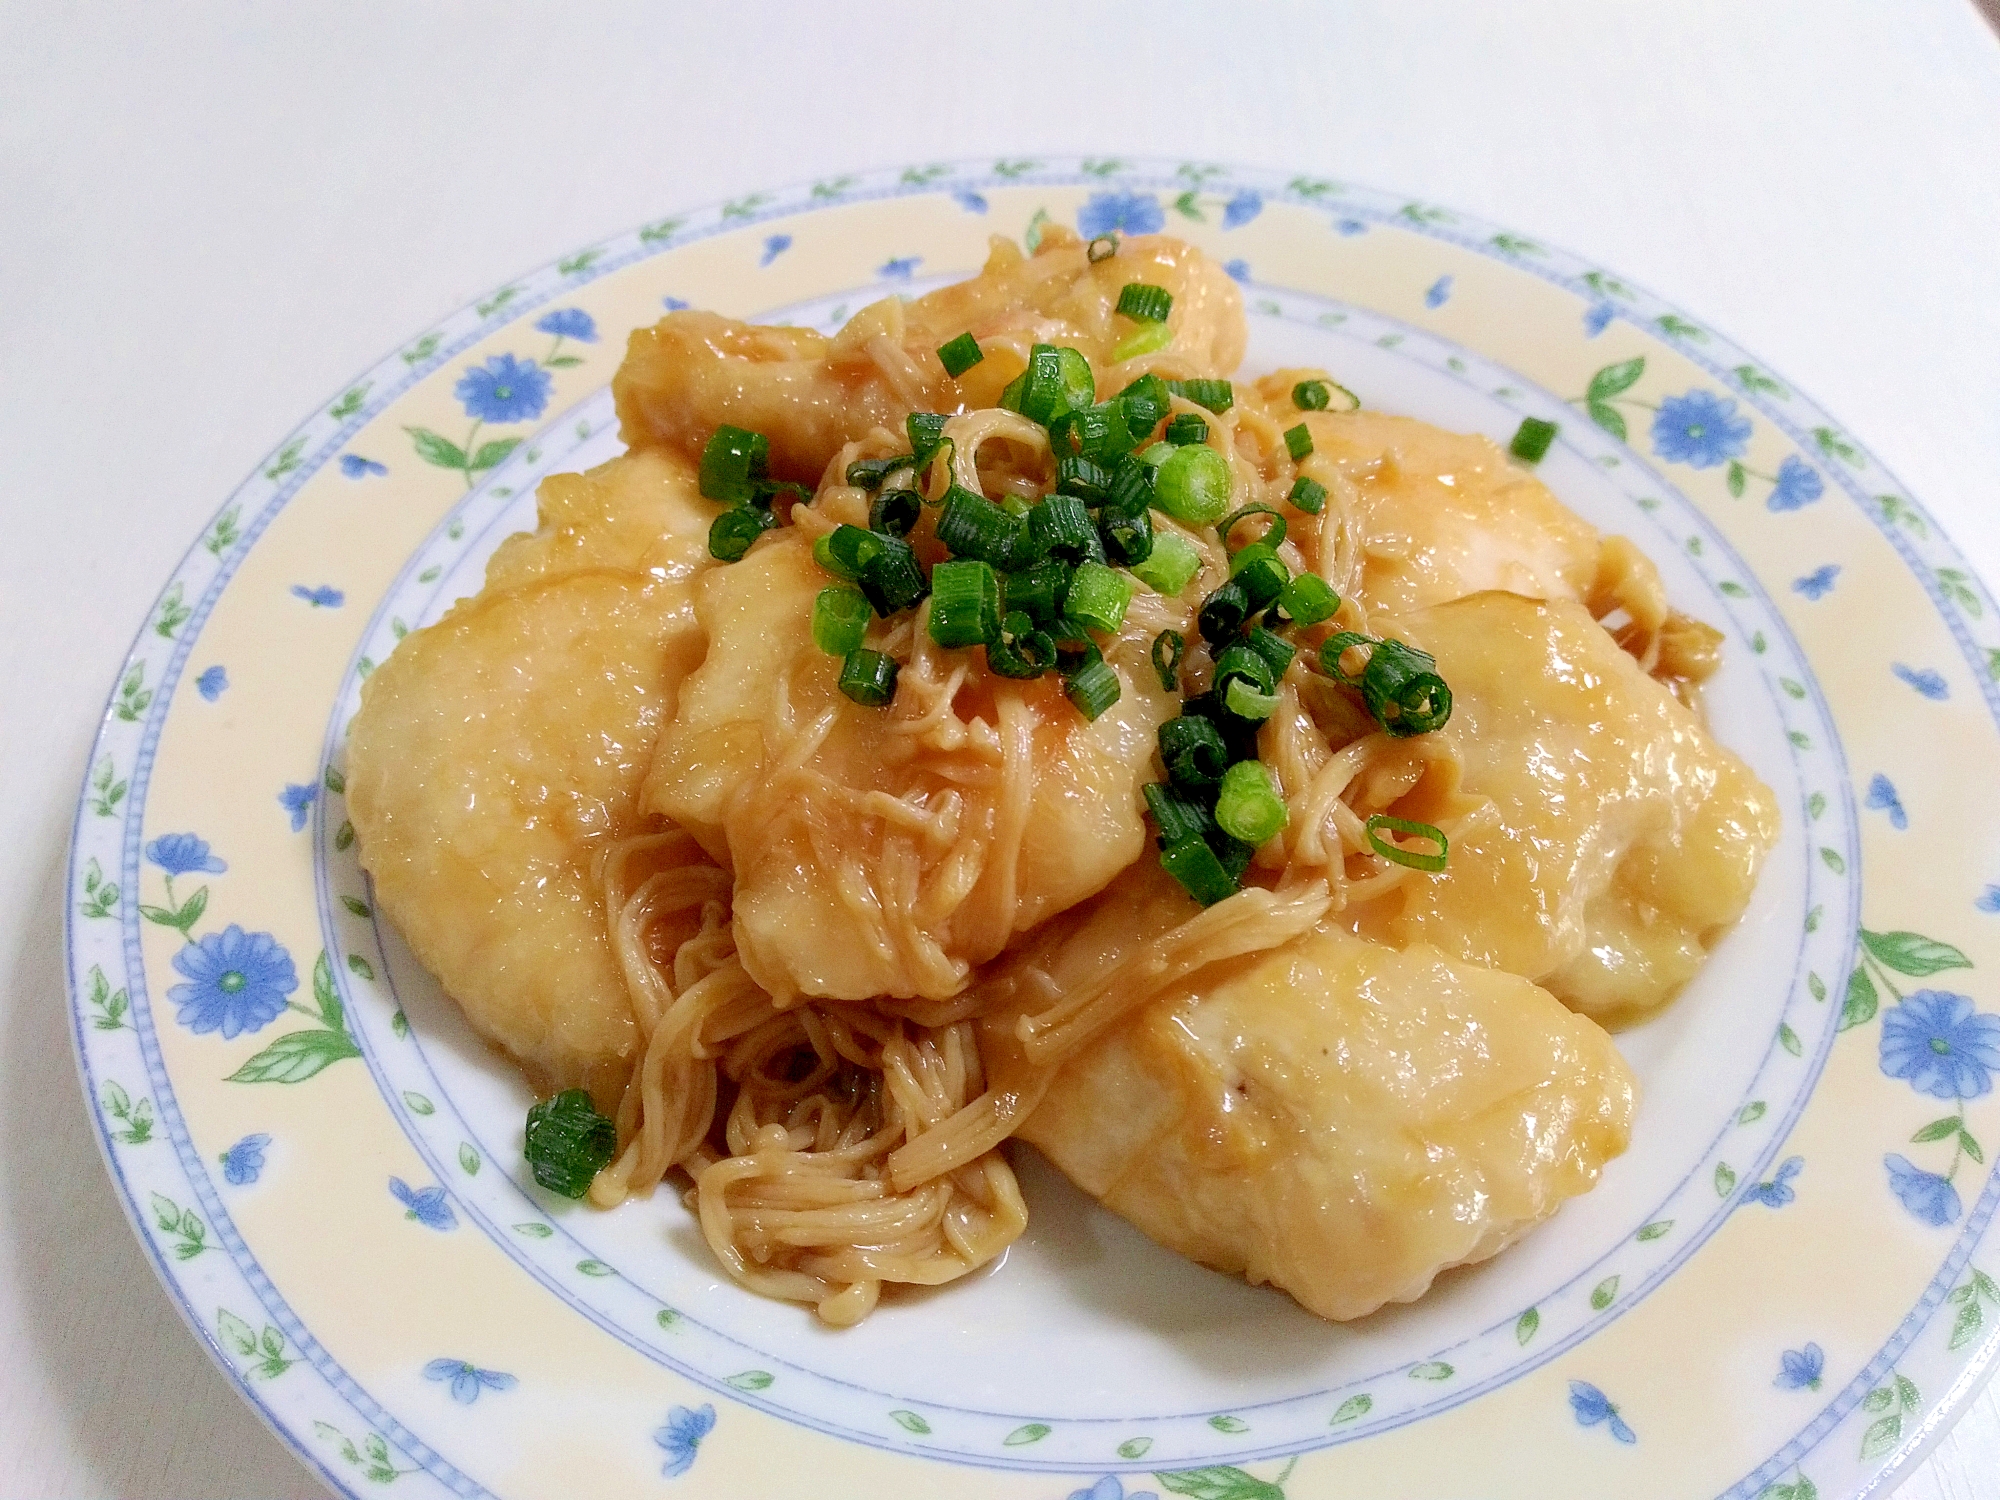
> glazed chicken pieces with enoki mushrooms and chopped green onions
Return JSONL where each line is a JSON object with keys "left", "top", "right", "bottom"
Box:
{"left": 348, "top": 230, "right": 1776, "bottom": 1324}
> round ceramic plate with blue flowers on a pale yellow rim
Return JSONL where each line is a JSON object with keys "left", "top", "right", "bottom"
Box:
{"left": 68, "top": 160, "right": 2000, "bottom": 1500}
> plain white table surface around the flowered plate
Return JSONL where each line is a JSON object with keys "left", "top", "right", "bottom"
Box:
{"left": 0, "top": 0, "right": 2000, "bottom": 1500}
